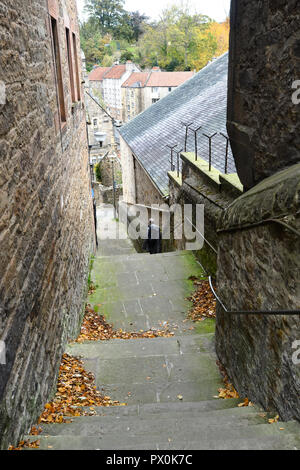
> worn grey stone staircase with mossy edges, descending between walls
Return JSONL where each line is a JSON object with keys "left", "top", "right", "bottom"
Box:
{"left": 25, "top": 210, "right": 300, "bottom": 450}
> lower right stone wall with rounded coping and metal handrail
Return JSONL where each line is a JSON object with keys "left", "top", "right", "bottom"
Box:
{"left": 216, "top": 164, "right": 300, "bottom": 420}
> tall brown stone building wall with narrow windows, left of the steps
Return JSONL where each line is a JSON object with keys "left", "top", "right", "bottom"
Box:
{"left": 0, "top": 0, "right": 94, "bottom": 449}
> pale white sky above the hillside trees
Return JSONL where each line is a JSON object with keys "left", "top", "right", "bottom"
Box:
{"left": 77, "top": 0, "right": 230, "bottom": 21}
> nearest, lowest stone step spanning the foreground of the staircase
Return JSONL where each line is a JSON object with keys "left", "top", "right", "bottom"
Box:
{"left": 25, "top": 423, "right": 300, "bottom": 450}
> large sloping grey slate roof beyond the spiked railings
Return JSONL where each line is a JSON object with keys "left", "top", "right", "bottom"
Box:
{"left": 119, "top": 53, "right": 236, "bottom": 195}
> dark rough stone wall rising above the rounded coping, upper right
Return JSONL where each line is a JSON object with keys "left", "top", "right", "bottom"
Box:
{"left": 227, "top": 0, "right": 300, "bottom": 189}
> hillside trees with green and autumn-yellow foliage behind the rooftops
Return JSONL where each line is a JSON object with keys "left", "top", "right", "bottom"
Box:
{"left": 80, "top": 0, "right": 229, "bottom": 71}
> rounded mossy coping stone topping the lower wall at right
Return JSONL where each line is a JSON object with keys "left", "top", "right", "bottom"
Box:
{"left": 218, "top": 163, "right": 300, "bottom": 230}
